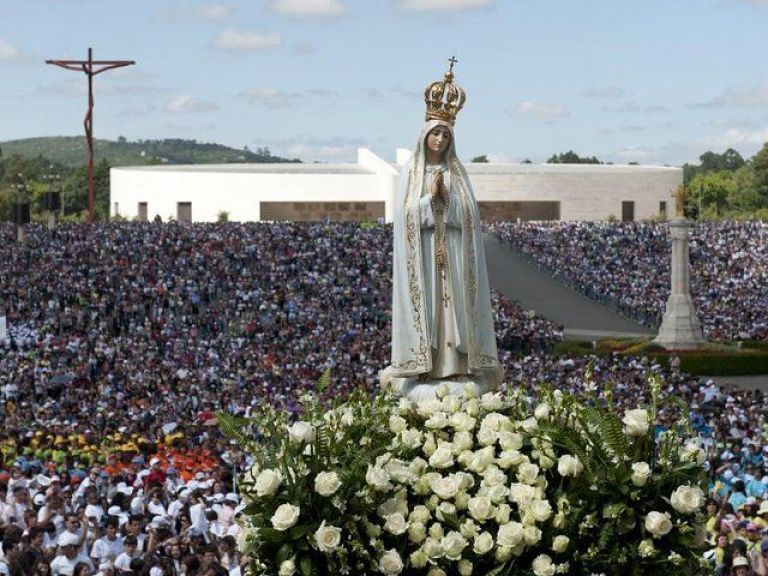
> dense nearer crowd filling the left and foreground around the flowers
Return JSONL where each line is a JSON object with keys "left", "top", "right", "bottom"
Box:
{"left": 0, "top": 223, "right": 768, "bottom": 576}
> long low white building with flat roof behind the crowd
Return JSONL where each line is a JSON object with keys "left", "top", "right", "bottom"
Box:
{"left": 110, "top": 149, "right": 683, "bottom": 222}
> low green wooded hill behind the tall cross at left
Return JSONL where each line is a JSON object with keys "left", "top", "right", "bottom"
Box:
{"left": 0, "top": 136, "right": 300, "bottom": 166}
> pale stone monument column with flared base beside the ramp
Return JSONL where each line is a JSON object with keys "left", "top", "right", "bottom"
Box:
{"left": 654, "top": 218, "right": 704, "bottom": 350}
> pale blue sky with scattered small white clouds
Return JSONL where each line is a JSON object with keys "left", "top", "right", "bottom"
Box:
{"left": 0, "top": 0, "right": 768, "bottom": 165}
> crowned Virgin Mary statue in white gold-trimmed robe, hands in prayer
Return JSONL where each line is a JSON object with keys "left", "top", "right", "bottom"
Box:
{"left": 382, "top": 60, "right": 502, "bottom": 400}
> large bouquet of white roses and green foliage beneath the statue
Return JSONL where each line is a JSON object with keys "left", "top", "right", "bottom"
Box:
{"left": 224, "top": 372, "right": 703, "bottom": 576}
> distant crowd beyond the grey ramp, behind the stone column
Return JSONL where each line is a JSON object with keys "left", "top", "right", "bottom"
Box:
{"left": 488, "top": 222, "right": 768, "bottom": 340}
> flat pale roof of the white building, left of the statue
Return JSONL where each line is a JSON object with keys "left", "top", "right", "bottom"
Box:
{"left": 112, "top": 162, "right": 374, "bottom": 174}
